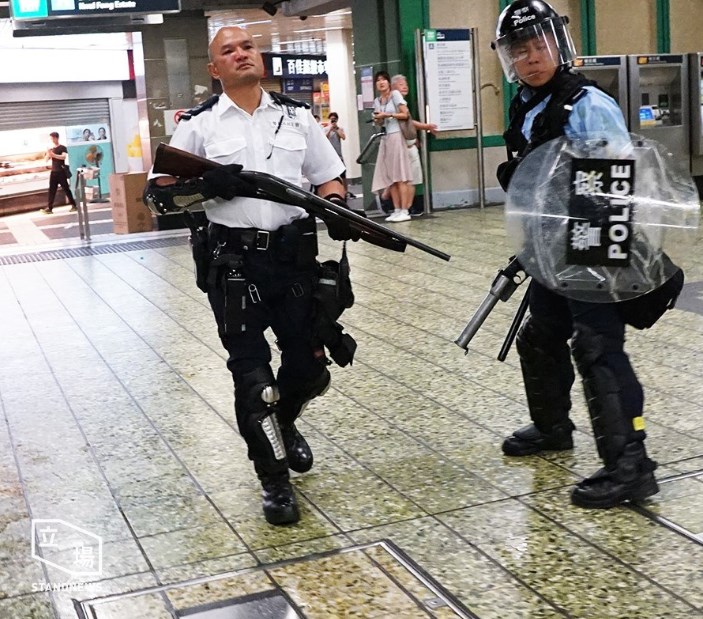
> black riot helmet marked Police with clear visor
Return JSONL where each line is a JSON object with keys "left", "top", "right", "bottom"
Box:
{"left": 491, "top": 0, "right": 576, "bottom": 82}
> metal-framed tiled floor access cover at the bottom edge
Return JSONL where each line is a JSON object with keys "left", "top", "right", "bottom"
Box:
{"left": 74, "top": 540, "right": 478, "bottom": 619}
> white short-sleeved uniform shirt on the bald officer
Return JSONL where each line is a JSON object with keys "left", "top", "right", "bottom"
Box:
{"left": 170, "top": 90, "right": 344, "bottom": 230}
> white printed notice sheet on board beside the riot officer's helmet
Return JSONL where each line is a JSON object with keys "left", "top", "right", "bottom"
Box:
{"left": 423, "top": 30, "right": 476, "bottom": 131}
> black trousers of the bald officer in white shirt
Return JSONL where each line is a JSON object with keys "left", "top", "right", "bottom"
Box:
{"left": 208, "top": 220, "right": 325, "bottom": 459}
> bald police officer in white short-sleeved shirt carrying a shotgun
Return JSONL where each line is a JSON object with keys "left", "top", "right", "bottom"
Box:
{"left": 145, "top": 27, "right": 359, "bottom": 525}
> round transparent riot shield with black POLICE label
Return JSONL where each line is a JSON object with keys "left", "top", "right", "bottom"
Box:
{"left": 505, "top": 135, "right": 700, "bottom": 303}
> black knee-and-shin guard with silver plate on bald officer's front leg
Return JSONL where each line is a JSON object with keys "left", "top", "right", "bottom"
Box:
{"left": 234, "top": 366, "right": 286, "bottom": 461}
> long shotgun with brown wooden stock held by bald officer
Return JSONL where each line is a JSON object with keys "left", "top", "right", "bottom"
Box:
{"left": 154, "top": 143, "right": 450, "bottom": 260}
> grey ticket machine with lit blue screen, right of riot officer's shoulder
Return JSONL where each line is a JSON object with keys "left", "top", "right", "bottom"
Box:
{"left": 628, "top": 54, "right": 691, "bottom": 167}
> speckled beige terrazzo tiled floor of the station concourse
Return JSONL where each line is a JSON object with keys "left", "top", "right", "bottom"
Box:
{"left": 0, "top": 207, "right": 703, "bottom": 619}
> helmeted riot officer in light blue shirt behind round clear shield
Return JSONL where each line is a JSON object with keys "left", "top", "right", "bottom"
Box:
{"left": 492, "top": 0, "right": 658, "bottom": 508}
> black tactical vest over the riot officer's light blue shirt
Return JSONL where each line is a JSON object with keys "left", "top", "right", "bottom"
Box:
{"left": 503, "top": 71, "right": 597, "bottom": 159}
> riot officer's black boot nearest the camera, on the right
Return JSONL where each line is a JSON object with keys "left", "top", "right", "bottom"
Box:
{"left": 571, "top": 441, "right": 659, "bottom": 509}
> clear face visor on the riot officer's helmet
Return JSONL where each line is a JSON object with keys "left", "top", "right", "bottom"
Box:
{"left": 493, "top": 17, "right": 576, "bottom": 82}
